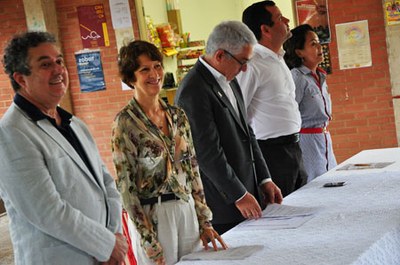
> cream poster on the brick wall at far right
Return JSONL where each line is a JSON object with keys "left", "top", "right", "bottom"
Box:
{"left": 336, "top": 20, "right": 372, "bottom": 70}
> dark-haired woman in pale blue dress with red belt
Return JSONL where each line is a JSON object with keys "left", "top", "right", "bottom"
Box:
{"left": 283, "top": 24, "right": 336, "bottom": 182}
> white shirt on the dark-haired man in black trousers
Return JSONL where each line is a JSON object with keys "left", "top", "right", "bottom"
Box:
{"left": 237, "top": 44, "right": 301, "bottom": 140}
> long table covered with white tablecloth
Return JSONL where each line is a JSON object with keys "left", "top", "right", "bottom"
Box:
{"left": 178, "top": 148, "right": 400, "bottom": 265}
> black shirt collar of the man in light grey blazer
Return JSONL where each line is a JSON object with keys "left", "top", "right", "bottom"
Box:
{"left": 14, "top": 93, "right": 72, "bottom": 124}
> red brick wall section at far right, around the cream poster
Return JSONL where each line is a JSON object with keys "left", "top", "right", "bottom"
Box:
{"left": 328, "top": 0, "right": 397, "bottom": 162}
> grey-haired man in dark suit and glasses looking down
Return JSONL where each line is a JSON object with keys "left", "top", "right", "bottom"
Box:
{"left": 175, "top": 21, "right": 282, "bottom": 234}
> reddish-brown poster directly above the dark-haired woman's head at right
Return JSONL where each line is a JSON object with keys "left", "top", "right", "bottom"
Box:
{"left": 295, "top": 0, "right": 331, "bottom": 43}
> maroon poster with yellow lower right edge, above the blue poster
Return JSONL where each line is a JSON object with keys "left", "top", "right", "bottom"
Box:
{"left": 77, "top": 4, "right": 110, "bottom": 48}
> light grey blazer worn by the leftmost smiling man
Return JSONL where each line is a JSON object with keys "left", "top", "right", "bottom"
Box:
{"left": 0, "top": 103, "right": 121, "bottom": 265}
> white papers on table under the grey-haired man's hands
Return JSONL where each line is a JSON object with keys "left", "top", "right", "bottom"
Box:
{"left": 238, "top": 204, "right": 317, "bottom": 230}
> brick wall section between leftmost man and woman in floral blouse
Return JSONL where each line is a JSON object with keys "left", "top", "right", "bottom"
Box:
{"left": 55, "top": 0, "right": 139, "bottom": 174}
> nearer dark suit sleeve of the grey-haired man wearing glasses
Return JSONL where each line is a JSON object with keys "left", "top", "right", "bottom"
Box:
{"left": 177, "top": 77, "right": 246, "bottom": 204}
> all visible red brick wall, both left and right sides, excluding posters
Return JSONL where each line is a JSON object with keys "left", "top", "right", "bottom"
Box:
{"left": 0, "top": 0, "right": 397, "bottom": 177}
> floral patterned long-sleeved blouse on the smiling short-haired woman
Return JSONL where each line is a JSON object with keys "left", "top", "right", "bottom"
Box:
{"left": 111, "top": 99, "right": 212, "bottom": 260}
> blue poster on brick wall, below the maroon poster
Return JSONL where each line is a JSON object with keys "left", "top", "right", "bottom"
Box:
{"left": 75, "top": 50, "right": 106, "bottom": 92}
